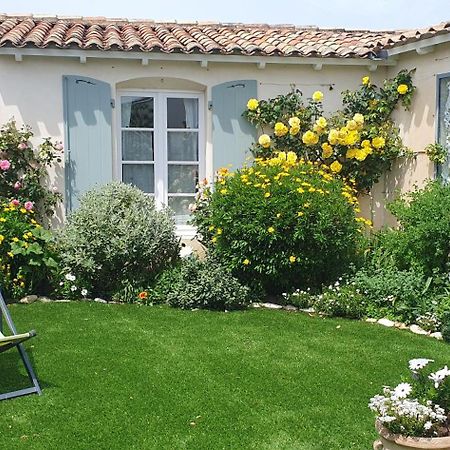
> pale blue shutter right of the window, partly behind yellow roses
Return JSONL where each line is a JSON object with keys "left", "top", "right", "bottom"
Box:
{"left": 211, "top": 80, "right": 257, "bottom": 171}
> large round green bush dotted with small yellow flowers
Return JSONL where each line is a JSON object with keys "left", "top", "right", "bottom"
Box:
{"left": 194, "top": 152, "right": 367, "bottom": 293}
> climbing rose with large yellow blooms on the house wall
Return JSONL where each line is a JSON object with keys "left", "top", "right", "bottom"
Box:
{"left": 244, "top": 71, "right": 415, "bottom": 192}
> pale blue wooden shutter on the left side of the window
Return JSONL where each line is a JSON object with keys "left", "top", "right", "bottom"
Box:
{"left": 63, "top": 75, "right": 112, "bottom": 211}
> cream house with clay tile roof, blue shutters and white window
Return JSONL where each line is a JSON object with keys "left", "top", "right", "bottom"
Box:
{"left": 0, "top": 15, "right": 450, "bottom": 236}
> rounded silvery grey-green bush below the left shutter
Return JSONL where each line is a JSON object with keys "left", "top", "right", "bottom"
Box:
{"left": 59, "top": 182, "right": 179, "bottom": 297}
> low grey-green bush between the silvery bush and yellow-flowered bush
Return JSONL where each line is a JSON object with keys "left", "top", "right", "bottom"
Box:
{"left": 167, "top": 257, "right": 250, "bottom": 310}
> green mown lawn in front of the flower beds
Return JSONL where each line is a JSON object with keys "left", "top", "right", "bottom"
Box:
{"left": 0, "top": 303, "right": 450, "bottom": 450}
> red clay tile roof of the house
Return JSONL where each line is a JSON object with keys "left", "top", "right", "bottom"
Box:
{"left": 0, "top": 14, "right": 450, "bottom": 58}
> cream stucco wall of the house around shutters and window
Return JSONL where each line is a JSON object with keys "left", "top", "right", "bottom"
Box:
{"left": 0, "top": 44, "right": 450, "bottom": 226}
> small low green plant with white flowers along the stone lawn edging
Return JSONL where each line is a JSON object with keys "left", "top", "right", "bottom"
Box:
{"left": 313, "top": 282, "right": 367, "bottom": 319}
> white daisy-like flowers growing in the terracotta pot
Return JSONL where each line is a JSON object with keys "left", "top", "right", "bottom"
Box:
{"left": 369, "top": 358, "right": 450, "bottom": 437}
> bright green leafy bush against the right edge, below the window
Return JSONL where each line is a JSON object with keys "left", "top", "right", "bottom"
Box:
{"left": 383, "top": 181, "right": 450, "bottom": 275}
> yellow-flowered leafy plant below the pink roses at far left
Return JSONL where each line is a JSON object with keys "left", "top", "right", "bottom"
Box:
{"left": 0, "top": 199, "right": 58, "bottom": 299}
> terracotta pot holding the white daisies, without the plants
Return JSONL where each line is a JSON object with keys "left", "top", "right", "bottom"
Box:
{"left": 373, "top": 420, "right": 450, "bottom": 450}
